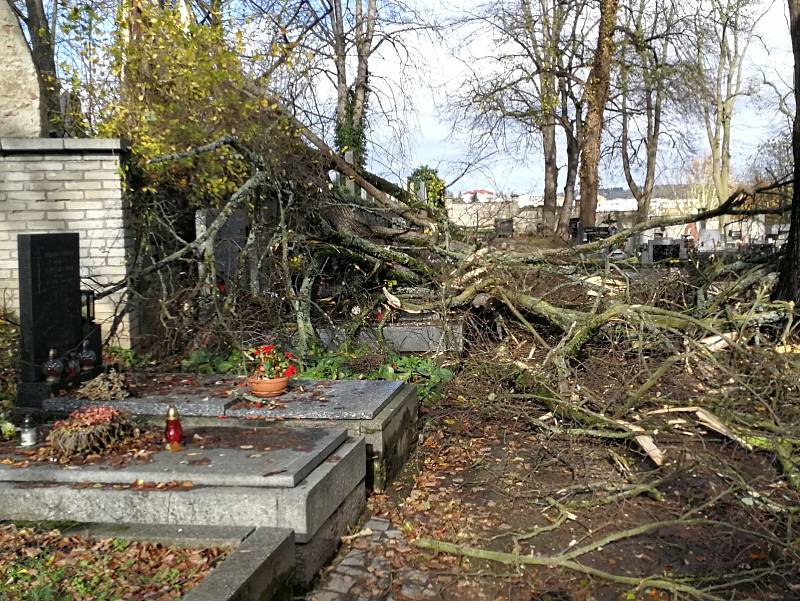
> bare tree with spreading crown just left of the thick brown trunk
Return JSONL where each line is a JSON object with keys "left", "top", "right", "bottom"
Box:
{"left": 459, "top": 0, "right": 592, "bottom": 232}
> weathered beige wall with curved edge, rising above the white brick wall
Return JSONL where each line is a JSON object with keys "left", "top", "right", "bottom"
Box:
{"left": 0, "top": 2, "right": 42, "bottom": 137}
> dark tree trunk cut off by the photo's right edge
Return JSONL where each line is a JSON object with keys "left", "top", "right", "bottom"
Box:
{"left": 775, "top": 0, "right": 800, "bottom": 304}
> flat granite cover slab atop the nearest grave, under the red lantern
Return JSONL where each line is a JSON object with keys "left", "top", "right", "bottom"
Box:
{"left": 0, "top": 425, "right": 347, "bottom": 488}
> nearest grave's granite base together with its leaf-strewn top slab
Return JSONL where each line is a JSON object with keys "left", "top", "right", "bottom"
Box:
{"left": 0, "top": 426, "right": 366, "bottom": 543}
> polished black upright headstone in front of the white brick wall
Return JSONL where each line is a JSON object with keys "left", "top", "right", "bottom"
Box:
{"left": 17, "top": 233, "right": 83, "bottom": 386}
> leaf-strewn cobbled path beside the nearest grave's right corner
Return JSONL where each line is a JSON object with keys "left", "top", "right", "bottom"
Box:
{"left": 305, "top": 518, "right": 442, "bottom": 601}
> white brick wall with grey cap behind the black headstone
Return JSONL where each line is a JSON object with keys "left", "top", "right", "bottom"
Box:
{"left": 0, "top": 138, "right": 138, "bottom": 347}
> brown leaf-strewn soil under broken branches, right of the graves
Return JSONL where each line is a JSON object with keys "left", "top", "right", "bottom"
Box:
{"left": 354, "top": 370, "right": 800, "bottom": 601}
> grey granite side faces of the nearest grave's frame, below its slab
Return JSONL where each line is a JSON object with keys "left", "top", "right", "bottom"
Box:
{"left": 0, "top": 439, "right": 366, "bottom": 543}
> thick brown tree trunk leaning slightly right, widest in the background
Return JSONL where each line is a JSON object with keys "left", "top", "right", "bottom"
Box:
{"left": 581, "top": 0, "right": 619, "bottom": 227}
